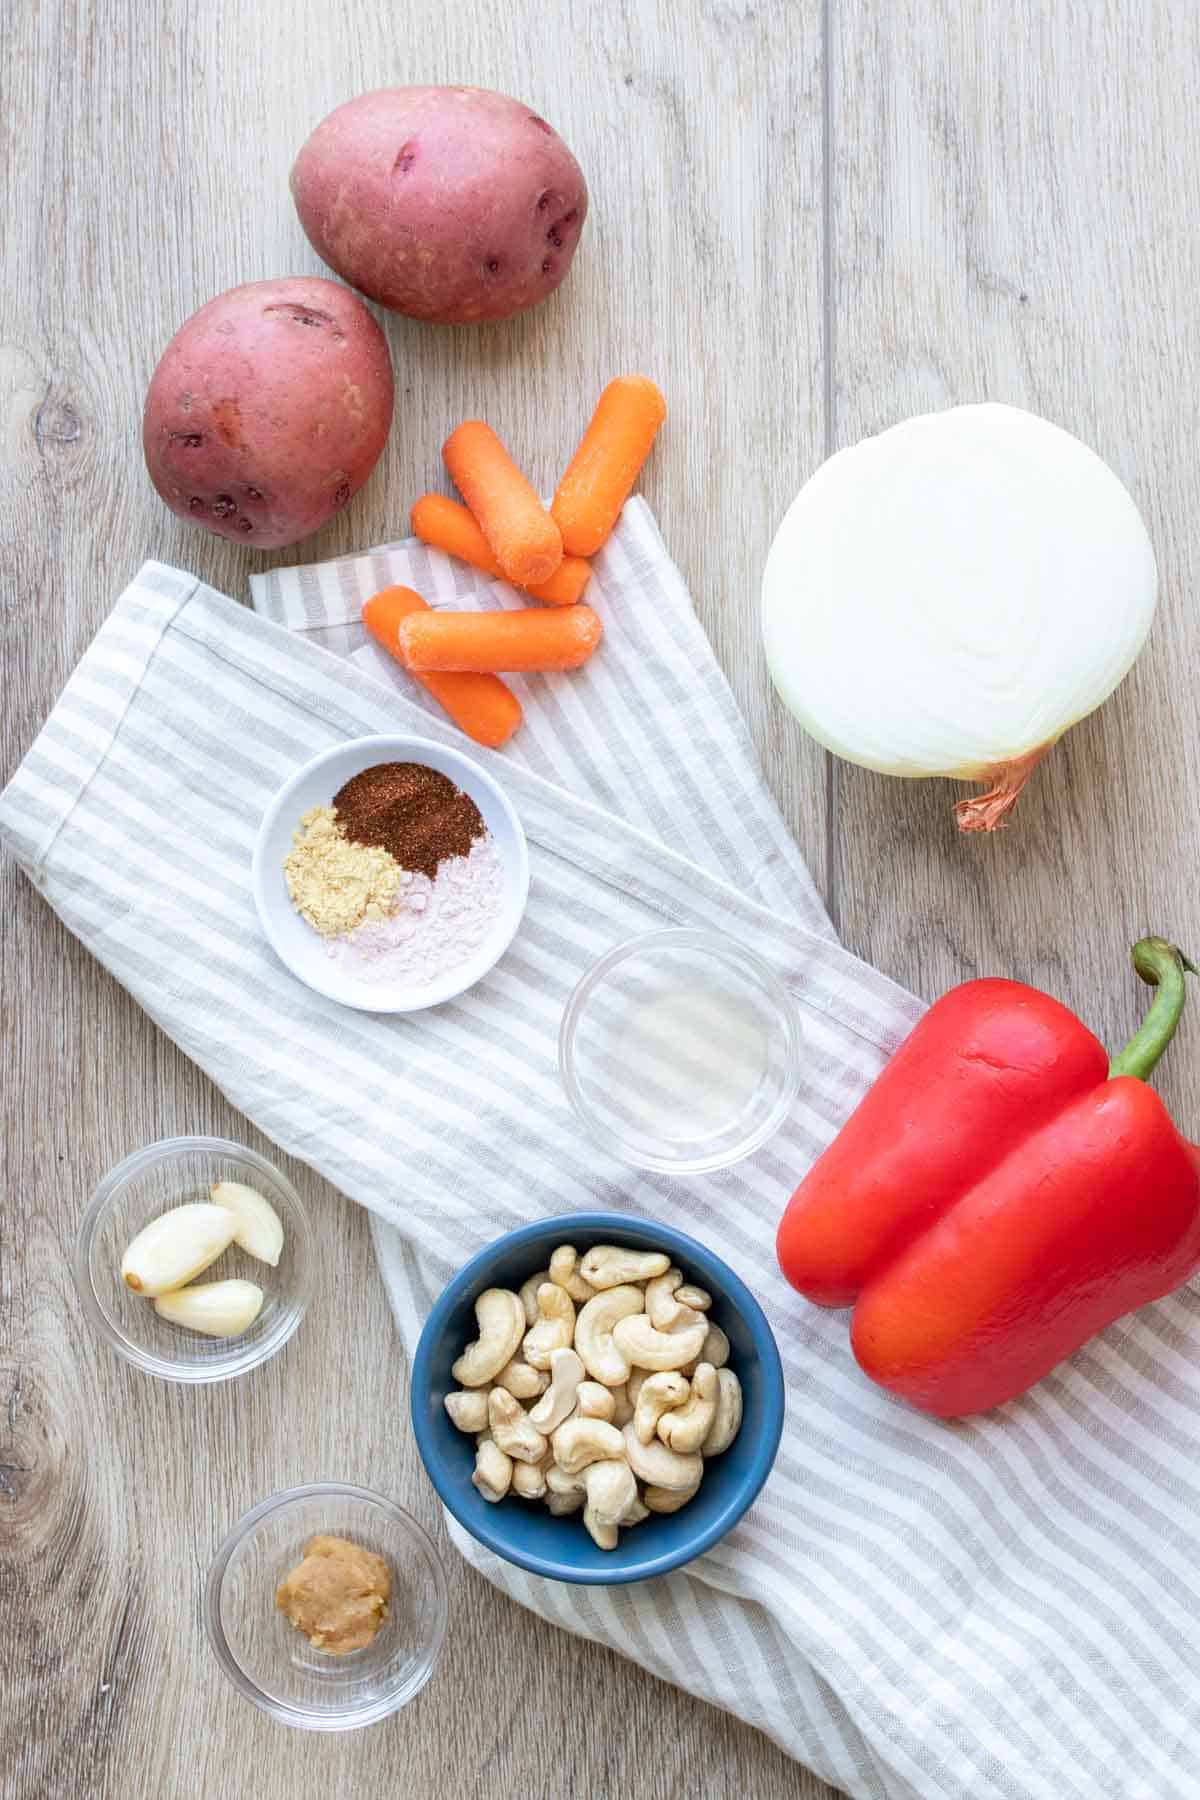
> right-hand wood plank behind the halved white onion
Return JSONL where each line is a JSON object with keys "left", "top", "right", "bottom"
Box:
{"left": 833, "top": 0, "right": 1200, "bottom": 1121}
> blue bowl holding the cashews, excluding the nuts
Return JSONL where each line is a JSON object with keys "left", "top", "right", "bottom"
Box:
{"left": 412, "top": 1213, "right": 783, "bottom": 1586}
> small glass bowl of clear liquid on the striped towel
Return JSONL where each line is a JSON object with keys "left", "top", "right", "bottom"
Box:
{"left": 558, "top": 929, "right": 801, "bottom": 1175}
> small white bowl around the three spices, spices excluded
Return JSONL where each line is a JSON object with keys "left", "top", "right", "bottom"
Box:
{"left": 254, "top": 736, "right": 529, "bottom": 1013}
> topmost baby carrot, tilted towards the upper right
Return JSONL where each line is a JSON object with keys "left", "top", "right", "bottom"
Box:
{"left": 551, "top": 374, "right": 667, "bottom": 556}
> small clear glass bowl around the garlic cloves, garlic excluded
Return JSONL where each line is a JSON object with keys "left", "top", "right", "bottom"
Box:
{"left": 76, "top": 1138, "right": 313, "bottom": 1382}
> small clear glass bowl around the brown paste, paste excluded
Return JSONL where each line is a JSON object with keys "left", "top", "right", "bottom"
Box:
{"left": 203, "top": 1481, "right": 446, "bottom": 1732}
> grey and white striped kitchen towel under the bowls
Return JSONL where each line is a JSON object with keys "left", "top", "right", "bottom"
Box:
{"left": 0, "top": 502, "right": 1200, "bottom": 1800}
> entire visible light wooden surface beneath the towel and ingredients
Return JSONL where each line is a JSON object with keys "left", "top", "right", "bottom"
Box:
{"left": 0, "top": 0, "right": 1200, "bottom": 1800}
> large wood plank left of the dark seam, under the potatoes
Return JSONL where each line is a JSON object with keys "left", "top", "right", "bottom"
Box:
{"left": 0, "top": 0, "right": 828, "bottom": 1800}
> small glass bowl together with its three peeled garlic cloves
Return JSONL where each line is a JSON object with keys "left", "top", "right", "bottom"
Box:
{"left": 74, "top": 1138, "right": 313, "bottom": 1382}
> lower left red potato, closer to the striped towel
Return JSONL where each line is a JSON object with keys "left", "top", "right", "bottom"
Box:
{"left": 142, "top": 275, "right": 392, "bottom": 549}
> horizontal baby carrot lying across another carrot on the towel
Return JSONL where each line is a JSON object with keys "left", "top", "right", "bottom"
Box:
{"left": 399, "top": 605, "right": 603, "bottom": 677}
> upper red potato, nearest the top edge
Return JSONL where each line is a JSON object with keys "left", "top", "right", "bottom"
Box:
{"left": 291, "top": 88, "right": 588, "bottom": 326}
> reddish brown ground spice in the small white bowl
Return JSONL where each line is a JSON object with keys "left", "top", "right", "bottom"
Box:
{"left": 333, "top": 763, "right": 486, "bottom": 880}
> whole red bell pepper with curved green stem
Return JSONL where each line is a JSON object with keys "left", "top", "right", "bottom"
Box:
{"left": 777, "top": 938, "right": 1200, "bottom": 1418}
